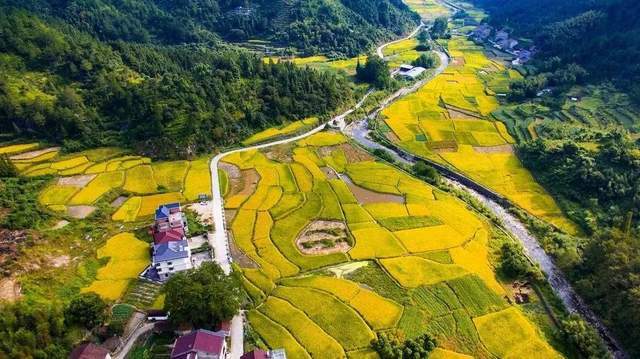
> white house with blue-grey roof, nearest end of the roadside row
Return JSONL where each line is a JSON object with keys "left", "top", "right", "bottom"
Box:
{"left": 151, "top": 239, "right": 193, "bottom": 281}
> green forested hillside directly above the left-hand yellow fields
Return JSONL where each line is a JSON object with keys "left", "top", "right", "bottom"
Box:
{"left": 0, "top": 8, "right": 350, "bottom": 157}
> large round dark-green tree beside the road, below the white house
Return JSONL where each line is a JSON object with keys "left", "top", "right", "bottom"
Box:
{"left": 164, "top": 263, "right": 241, "bottom": 328}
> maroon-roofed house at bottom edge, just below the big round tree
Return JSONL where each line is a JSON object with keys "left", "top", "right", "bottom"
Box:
{"left": 171, "top": 329, "right": 227, "bottom": 359}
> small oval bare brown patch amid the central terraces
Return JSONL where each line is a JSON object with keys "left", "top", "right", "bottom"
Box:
{"left": 296, "top": 221, "right": 351, "bottom": 255}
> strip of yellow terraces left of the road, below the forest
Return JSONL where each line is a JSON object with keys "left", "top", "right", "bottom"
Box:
{"left": 0, "top": 143, "right": 211, "bottom": 222}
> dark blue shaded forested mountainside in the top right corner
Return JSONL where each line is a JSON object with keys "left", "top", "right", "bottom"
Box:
{"left": 473, "top": 0, "right": 640, "bottom": 100}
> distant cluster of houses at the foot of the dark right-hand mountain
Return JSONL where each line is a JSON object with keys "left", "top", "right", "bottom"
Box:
{"left": 469, "top": 24, "right": 536, "bottom": 65}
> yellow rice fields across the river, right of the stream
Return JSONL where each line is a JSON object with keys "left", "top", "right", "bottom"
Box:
{"left": 382, "top": 21, "right": 579, "bottom": 234}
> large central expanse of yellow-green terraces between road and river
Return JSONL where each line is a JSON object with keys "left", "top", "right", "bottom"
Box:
{"left": 221, "top": 132, "right": 558, "bottom": 358}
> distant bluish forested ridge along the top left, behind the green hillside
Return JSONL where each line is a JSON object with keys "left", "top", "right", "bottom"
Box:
{"left": 2, "top": 0, "right": 417, "bottom": 55}
